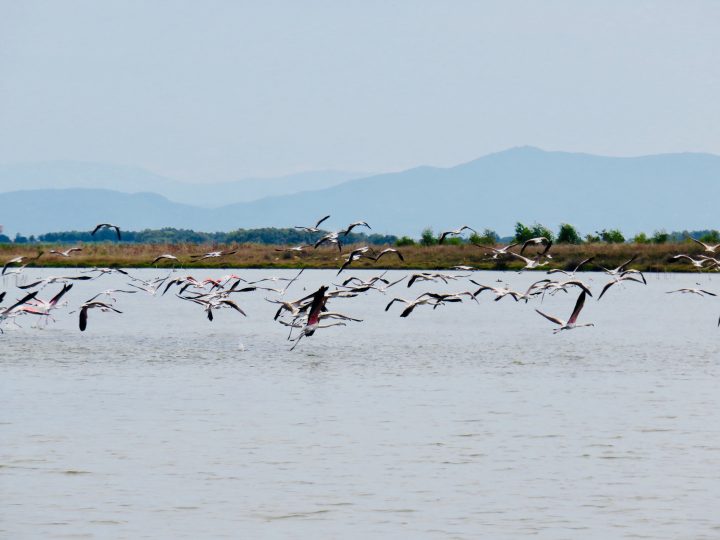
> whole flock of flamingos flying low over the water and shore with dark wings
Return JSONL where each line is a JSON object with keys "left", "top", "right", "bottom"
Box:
{"left": 0, "top": 215, "right": 720, "bottom": 342}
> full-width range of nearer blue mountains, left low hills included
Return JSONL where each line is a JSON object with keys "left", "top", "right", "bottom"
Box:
{"left": 0, "top": 147, "right": 720, "bottom": 237}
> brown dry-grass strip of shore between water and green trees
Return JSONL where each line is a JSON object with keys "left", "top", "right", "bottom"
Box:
{"left": 0, "top": 242, "right": 702, "bottom": 272}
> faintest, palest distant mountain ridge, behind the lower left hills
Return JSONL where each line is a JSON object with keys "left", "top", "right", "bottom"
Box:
{"left": 0, "top": 161, "right": 367, "bottom": 208}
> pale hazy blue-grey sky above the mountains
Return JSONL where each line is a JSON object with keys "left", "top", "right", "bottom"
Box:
{"left": 0, "top": 0, "right": 720, "bottom": 181}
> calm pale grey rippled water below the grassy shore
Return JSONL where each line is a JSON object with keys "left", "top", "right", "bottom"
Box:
{"left": 0, "top": 270, "right": 720, "bottom": 539}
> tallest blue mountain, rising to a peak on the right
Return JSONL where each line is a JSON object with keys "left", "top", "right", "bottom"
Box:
{"left": 208, "top": 147, "right": 720, "bottom": 237}
